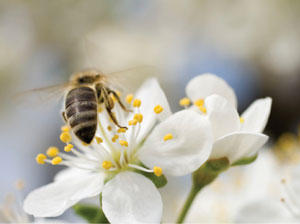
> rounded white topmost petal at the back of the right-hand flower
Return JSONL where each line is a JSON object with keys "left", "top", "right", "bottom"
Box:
{"left": 185, "top": 73, "right": 237, "bottom": 107}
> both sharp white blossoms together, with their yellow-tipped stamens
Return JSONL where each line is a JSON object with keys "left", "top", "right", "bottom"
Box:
{"left": 24, "top": 74, "right": 272, "bottom": 223}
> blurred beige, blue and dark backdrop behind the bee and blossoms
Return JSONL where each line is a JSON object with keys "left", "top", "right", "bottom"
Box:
{"left": 0, "top": 0, "right": 300, "bottom": 220}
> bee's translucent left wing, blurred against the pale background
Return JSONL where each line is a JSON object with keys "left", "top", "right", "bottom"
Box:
{"left": 14, "top": 82, "right": 70, "bottom": 107}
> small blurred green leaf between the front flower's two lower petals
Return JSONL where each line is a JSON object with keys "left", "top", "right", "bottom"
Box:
{"left": 73, "top": 204, "right": 108, "bottom": 223}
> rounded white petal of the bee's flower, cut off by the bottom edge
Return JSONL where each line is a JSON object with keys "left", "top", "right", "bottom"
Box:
{"left": 102, "top": 172, "right": 163, "bottom": 223}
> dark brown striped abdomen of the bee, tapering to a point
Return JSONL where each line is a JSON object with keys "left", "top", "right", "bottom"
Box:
{"left": 65, "top": 87, "right": 97, "bottom": 143}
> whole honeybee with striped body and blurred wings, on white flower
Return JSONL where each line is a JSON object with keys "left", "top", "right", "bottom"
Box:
{"left": 22, "top": 66, "right": 157, "bottom": 144}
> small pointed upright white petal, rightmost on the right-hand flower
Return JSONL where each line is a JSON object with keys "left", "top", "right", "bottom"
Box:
{"left": 241, "top": 97, "right": 272, "bottom": 133}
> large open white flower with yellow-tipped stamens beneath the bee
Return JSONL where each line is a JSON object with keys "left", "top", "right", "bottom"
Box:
{"left": 24, "top": 79, "right": 212, "bottom": 223}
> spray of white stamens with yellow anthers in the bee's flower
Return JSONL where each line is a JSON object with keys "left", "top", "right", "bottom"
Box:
{"left": 36, "top": 94, "right": 166, "bottom": 176}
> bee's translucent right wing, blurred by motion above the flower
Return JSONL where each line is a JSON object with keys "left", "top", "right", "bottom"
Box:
{"left": 105, "top": 65, "right": 160, "bottom": 93}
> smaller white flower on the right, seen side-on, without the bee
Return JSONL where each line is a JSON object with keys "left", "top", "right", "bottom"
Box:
{"left": 181, "top": 74, "right": 272, "bottom": 163}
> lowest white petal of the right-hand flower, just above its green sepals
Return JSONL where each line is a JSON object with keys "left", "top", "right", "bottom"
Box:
{"left": 210, "top": 132, "right": 268, "bottom": 163}
